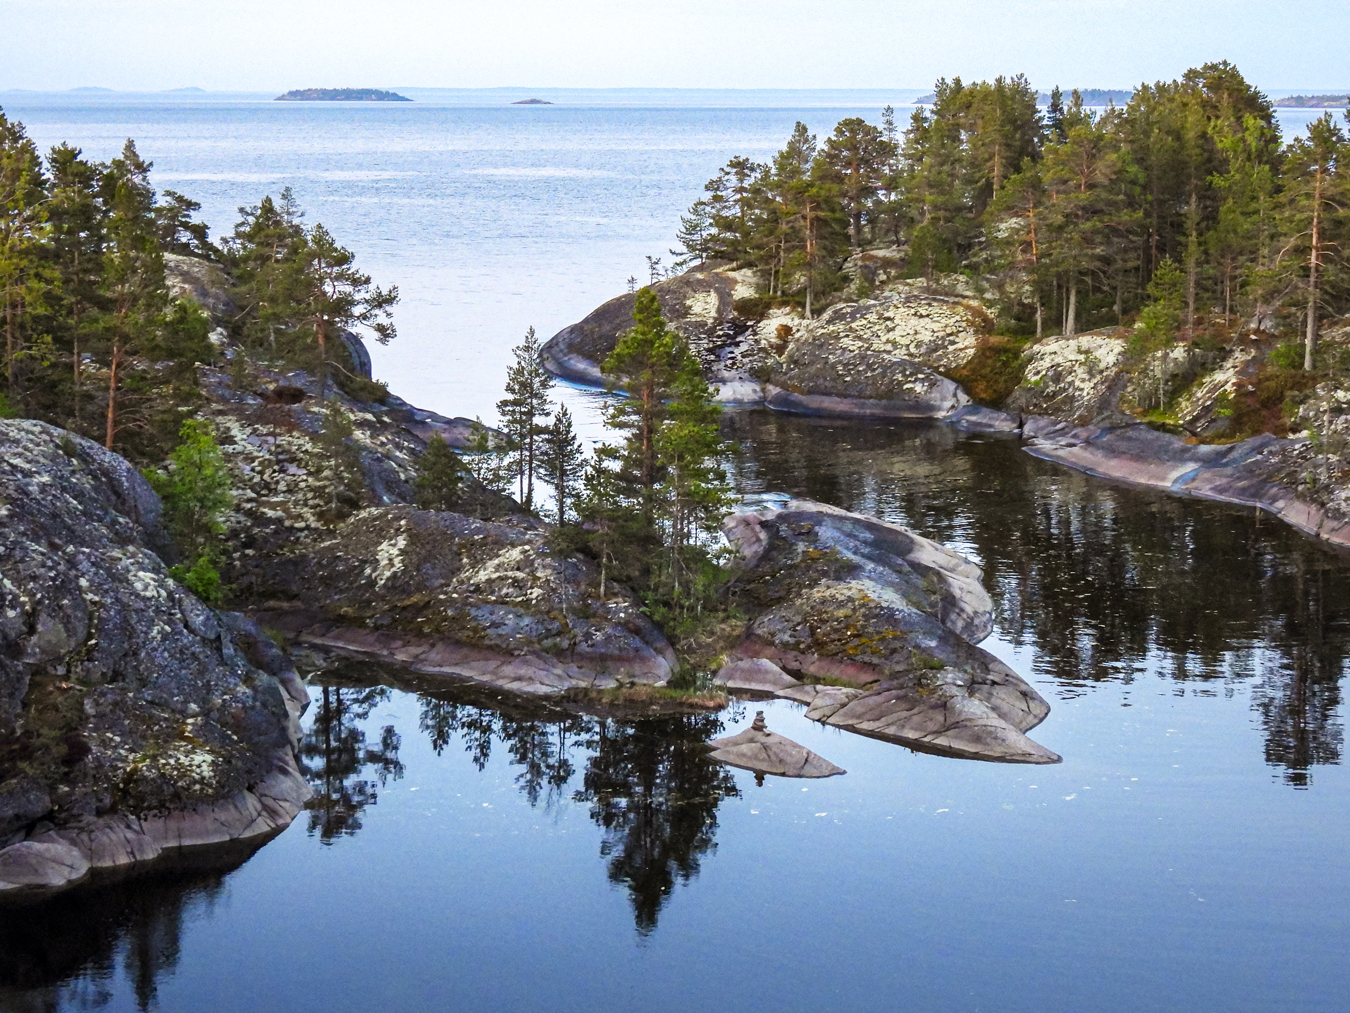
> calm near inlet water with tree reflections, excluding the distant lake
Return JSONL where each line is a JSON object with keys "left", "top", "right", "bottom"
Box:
{"left": 0, "top": 412, "right": 1350, "bottom": 1013}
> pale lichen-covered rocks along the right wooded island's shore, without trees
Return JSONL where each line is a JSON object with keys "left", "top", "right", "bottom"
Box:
{"left": 543, "top": 262, "right": 1350, "bottom": 551}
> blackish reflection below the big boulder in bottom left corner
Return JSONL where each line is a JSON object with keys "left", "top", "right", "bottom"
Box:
{"left": 0, "top": 840, "right": 262, "bottom": 1013}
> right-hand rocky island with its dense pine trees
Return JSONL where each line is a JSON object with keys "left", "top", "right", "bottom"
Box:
{"left": 543, "top": 63, "right": 1350, "bottom": 544}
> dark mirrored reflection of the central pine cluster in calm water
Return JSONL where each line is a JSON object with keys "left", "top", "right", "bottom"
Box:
{"left": 420, "top": 697, "right": 737, "bottom": 935}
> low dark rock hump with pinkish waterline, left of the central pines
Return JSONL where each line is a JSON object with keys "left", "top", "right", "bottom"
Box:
{"left": 255, "top": 507, "right": 676, "bottom": 694}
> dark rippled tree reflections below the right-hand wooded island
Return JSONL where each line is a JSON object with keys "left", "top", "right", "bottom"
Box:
{"left": 728, "top": 412, "right": 1350, "bottom": 786}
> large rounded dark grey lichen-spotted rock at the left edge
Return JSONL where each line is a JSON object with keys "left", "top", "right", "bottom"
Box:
{"left": 0, "top": 420, "right": 309, "bottom": 890}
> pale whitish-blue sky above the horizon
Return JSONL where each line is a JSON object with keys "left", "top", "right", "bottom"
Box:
{"left": 10, "top": 0, "right": 1350, "bottom": 92}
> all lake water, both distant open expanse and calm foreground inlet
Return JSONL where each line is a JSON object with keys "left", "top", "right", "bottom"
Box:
{"left": 0, "top": 93, "right": 1350, "bottom": 1013}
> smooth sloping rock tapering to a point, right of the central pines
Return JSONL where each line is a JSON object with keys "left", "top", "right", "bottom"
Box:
{"left": 718, "top": 500, "right": 1060, "bottom": 763}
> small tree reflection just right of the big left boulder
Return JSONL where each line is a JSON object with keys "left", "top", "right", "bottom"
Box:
{"left": 300, "top": 685, "right": 404, "bottom": 844}
